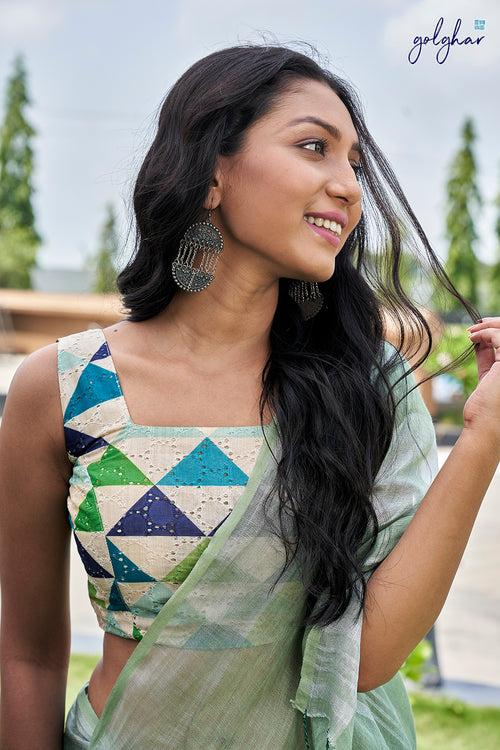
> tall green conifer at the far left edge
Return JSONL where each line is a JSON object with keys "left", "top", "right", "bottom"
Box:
{"left": 0, "top": 55, "right": 41, "bottom": 288}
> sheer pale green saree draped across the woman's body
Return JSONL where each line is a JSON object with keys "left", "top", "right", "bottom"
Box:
{"left": 89, "top": 343, "right": 437, "bottom": 750}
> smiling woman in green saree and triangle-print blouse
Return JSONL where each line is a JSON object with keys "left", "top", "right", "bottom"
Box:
{"left": 0, "top": 45, "right": 500, "bottom": 750}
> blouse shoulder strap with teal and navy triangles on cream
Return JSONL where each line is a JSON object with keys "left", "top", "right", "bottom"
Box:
{"left": 57, "top": 328, "right": 126, "bottom": 462}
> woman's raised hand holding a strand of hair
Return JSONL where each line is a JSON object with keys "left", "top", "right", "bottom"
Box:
{"left": 464, "top": 317, "right": 500, "bottom": 449}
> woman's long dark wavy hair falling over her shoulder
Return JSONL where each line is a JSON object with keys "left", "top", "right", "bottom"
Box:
{"left": 117, "top": 44, "right": 480, "bottom": 626}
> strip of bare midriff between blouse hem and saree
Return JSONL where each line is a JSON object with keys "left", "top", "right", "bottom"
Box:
{"left": 88, "top": 633, "right": 139, "bottom": 718}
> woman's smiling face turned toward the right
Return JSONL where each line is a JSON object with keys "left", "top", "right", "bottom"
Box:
{"left": 213, "top": 80, "right": 361, "bottom": 281}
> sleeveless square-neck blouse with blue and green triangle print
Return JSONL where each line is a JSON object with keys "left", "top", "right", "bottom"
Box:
{"left": 57, "top": 328, "right": 270, "bottom": 641}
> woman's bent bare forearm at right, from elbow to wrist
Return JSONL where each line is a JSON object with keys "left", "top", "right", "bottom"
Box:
{"left": 359, "top": 429, "right": 500, "bottom": 692}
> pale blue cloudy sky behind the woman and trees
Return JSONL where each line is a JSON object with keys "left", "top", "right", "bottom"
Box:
{"left": 0, "top": 0, "right": 500, "bottom": 269}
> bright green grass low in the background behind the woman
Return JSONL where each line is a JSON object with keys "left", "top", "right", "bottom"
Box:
{"left": 66, "top": 654, "right": 500, "bottom": 750}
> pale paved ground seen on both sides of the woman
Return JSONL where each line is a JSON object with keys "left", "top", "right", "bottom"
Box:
{"left": 0, "top": 355, "right": 500, "bottom": 705}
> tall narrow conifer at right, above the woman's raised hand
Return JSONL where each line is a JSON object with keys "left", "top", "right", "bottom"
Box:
{"left": 445, "top": 117, "right": 483, "bottom": 310}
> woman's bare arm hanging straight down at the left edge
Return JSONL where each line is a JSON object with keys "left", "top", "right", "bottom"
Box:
{"left": 0, "top": 344, "right": 71, "bottom": 750}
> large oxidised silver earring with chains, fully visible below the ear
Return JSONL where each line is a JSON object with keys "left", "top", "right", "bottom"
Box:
{"left": 172, "top": 208, "right": 224, "bottom": 292}
